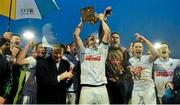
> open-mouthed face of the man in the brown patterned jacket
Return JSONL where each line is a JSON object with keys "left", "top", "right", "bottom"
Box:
{"left": 111, "top": 33, "right": 120, "bottom": 47}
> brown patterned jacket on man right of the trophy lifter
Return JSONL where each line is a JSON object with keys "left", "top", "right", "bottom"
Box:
{"left": 106, "top": 47, "right": 131, "bottom": 82}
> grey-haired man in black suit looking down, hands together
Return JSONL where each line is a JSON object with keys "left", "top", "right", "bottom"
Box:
{"left": 36, "top": 44, "right": 73, "bottom": 104}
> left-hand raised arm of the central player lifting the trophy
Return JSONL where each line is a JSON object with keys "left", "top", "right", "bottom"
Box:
{"left": 74, "top": 19, "right": 83, "bottom": 48}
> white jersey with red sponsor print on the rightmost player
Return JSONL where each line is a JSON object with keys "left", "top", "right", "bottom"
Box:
{"left": 153, "top": 58, "right": 180, "bottom": 97}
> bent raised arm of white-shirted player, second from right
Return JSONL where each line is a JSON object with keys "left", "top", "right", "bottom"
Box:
{"left": 135, "top": 33, "right": 159, "bottom": 61}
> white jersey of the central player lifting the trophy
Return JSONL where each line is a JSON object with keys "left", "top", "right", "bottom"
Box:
{"left": 79, "top": 43, "right": 109, "bottom": 85}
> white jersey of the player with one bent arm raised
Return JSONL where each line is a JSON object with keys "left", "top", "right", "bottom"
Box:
{"left": 129, "top": 55, "right": 154, "bottom": 90}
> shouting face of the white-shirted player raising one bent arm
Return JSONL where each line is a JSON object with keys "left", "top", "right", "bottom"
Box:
{"left": 132, "top": 42, "right": 144, "bottom": 58}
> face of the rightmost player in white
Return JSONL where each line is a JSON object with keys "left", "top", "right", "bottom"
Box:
{"left": 158, "top": 44, "right": 170, "bottom": 58}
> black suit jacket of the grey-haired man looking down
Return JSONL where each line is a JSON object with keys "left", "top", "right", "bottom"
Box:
{"left": 36, "top": 56, "right": 70, "bottom": 104}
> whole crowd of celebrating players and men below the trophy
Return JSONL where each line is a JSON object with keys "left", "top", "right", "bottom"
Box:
{"left": 0, "top": 6, "right": 180, "bottom": 104}
